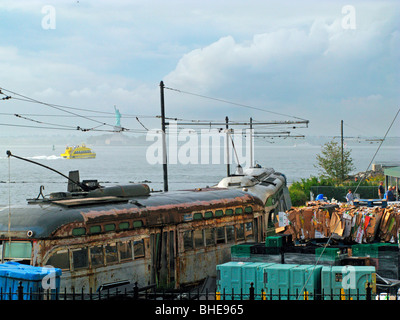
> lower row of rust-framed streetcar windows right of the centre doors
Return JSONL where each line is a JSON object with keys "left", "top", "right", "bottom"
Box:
{"left": 182, "top": 222, "right": 254, "bottom": 251}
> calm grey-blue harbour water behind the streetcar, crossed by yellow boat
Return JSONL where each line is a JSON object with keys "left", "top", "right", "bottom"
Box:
{"left": 0, "top": 144, "right": 400, "bottom": 206}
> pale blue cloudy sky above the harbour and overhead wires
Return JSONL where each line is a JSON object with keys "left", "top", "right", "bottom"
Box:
{"left": 0, "top": 0, "right": 400, "bottom": 137}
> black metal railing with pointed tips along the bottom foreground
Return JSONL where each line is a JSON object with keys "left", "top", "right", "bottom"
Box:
{"left": 0, "top": 283, "right": 386, "bottom": 301}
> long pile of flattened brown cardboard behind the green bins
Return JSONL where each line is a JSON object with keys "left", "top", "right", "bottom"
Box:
{"left": 285, "top": 202, "right": 400, "bottom": 243}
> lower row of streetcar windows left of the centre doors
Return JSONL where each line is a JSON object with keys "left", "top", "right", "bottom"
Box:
{"left": 46, "top": 239, "right": 145, "bottom": 270}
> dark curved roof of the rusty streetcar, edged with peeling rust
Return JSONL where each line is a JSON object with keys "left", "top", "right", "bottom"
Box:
{"left": 0, "top": 188, "right": 263, "bottom": 239}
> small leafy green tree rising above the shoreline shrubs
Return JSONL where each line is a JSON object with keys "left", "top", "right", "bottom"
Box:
{"left": 316, "top": 140, "right": 355, "bottom": 183}
